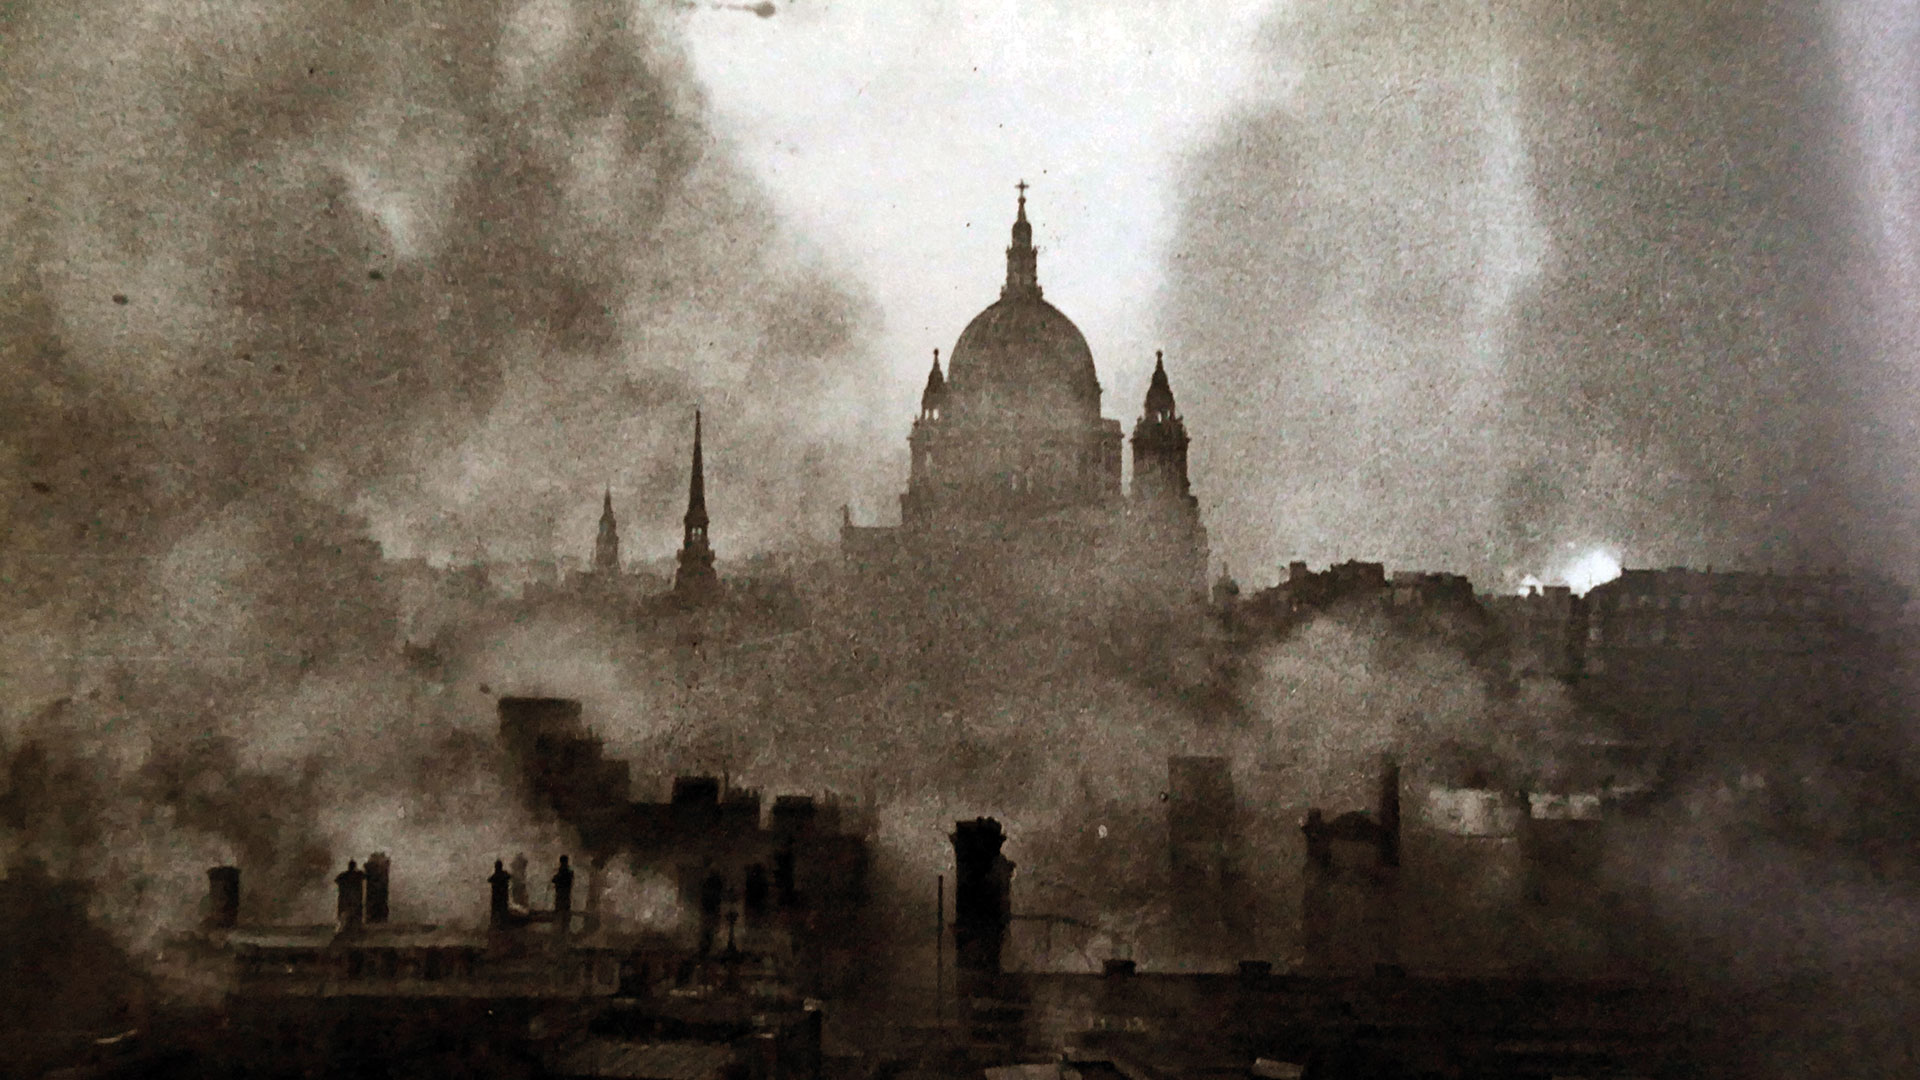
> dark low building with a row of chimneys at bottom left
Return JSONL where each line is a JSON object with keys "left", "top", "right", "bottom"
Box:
{"left": 154, "top": 855, "right": 822, "bottom": 1080}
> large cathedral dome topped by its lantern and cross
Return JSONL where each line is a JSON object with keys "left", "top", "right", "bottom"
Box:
{"left": 947, "top": 184, "right": 1100, "bottom": 427}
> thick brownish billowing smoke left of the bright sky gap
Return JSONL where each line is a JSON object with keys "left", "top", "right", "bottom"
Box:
{"left": 0, "top": 0, "right": 870, "bottom": 1014}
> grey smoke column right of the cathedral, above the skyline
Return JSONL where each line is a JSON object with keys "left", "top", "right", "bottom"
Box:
{"left": 1164, "top": 0, "right": 1914, "bottom": 582}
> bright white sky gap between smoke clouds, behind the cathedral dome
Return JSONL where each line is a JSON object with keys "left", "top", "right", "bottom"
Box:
{"left": 687, "top": 0, "right": 1265, "bottom": 428}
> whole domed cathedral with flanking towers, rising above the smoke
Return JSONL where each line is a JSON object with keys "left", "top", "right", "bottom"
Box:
{"left": 841, "top": 184, "right": 1208, "bottom": 598}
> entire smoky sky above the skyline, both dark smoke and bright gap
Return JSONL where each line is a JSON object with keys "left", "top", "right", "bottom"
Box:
{"left": 0, "top": 0, "right": 1920, "bottom": 584}
